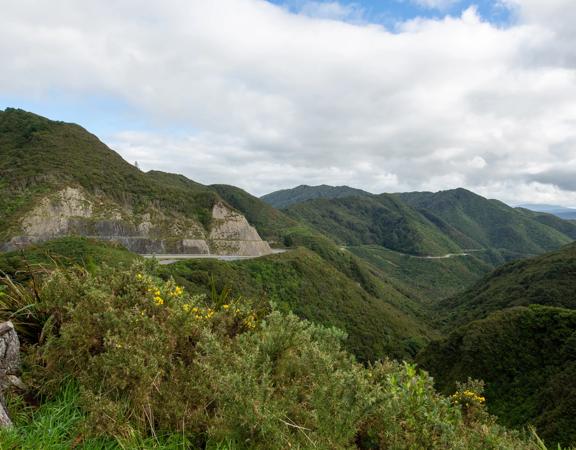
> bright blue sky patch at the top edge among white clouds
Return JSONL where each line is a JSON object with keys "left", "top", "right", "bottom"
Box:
{"left": 268, "top": 0, "right": 514, "bottom": 31}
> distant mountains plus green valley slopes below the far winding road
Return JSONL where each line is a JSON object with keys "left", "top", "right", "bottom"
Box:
{"left": 282, "top": 185, "right": 576, "bottom": 302}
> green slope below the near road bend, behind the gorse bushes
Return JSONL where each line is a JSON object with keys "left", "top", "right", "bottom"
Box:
{"left": 165, "top": 248, "right": 436, "bottom": 361}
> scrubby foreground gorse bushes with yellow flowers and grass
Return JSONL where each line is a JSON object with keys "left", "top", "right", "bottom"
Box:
{"left": 0, "top": 263, "right": 542, "bottom": 449}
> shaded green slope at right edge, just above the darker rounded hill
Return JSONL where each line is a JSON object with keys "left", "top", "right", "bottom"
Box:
{"left": 435, "top": 244, "right": 576, "bottom": 328}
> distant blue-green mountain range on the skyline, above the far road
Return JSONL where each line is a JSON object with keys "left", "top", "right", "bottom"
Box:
{"left": 262, "top": 185, "right": 576, "bottom": 259}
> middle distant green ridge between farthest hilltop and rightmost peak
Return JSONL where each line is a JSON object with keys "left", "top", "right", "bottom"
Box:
{"left": 284, "top": 194, "right": 460, "bottom": 255}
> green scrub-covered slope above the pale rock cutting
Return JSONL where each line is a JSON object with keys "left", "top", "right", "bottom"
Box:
{"left": 0, "top": 108, "right": 218, "bottom": 240}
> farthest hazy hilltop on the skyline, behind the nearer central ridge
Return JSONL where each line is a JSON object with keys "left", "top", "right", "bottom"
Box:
{"left": 260, "top": 184, "right": 372, "bottom": 209}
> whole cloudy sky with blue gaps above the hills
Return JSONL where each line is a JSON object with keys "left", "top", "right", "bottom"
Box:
{"left": 0, "top": 0, "right": 576, "bottom": 206}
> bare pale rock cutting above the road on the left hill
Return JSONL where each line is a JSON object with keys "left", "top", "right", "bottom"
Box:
{"left": 0, "top": 187, "right": 271, "bottom": 256}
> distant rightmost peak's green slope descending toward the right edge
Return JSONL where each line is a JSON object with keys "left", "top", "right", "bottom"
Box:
{"left": 395, "top": 189, "right": 573, "bottom": 258}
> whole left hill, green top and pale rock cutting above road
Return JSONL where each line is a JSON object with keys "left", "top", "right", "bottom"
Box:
{"left": 0, "top": 108, "right": 270, "bottom": 255}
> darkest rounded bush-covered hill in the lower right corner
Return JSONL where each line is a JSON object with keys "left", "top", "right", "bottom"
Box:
{"left": 418, "top": 306, "right": 576, "bottom": 446}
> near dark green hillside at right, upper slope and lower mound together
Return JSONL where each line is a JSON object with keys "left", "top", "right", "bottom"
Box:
{"left": 417, "top": 244, "right": 576, "bottom": 445}
